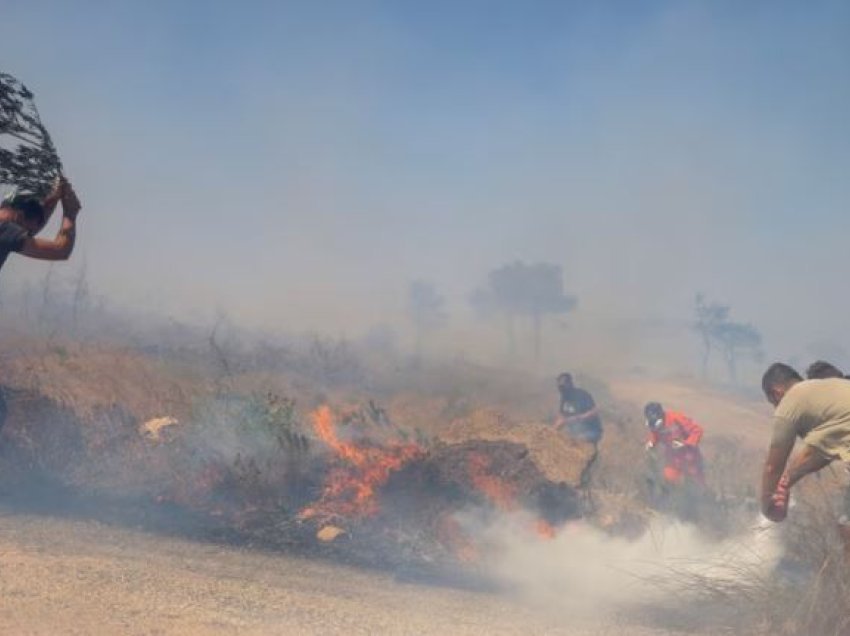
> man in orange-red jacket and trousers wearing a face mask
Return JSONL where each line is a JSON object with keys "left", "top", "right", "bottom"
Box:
{"left": 643, "top": 402, "right": 705, "bottom": 486}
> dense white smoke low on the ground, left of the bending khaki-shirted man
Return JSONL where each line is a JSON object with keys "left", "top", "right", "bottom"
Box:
{"left": 470, "top": 515, "right": 782, "bottom": 620}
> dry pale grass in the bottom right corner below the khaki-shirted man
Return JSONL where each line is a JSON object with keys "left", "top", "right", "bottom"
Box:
{"left": 652, "top": 485, "right": 850, "bottom": 636}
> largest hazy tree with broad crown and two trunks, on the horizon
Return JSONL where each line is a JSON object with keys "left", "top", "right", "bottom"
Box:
{"left": 469, "top": 261, "right": 577, "bottom": 360}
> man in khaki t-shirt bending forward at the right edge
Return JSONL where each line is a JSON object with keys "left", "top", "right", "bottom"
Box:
{"left": 761, "top": 362, "right": 850, "bottom": 521}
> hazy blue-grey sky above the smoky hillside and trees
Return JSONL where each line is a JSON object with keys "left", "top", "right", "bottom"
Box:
{"left": 0, "top": 0, "right": 850, "bottom": 368}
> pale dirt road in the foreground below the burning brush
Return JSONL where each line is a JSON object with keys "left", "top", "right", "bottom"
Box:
{"left": 0, "top": 513, "right": 680, "bottom": 636}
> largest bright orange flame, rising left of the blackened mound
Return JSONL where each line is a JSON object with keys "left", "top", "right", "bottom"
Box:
{"left": 300, "top": 406, "right": 423, "bottom": 519}
